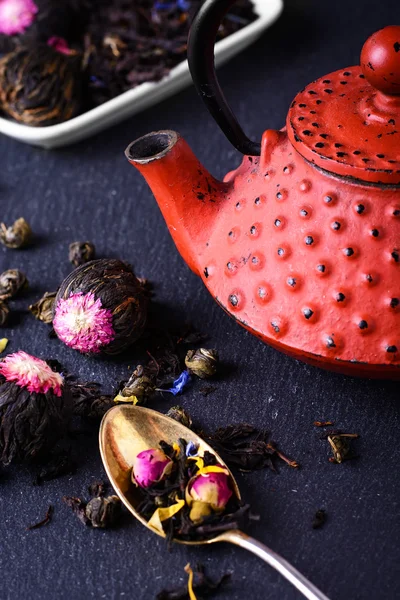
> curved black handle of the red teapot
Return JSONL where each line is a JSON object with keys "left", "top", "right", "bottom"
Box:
{"left": 188, "top": 0, "right": 261, "bottom": 156}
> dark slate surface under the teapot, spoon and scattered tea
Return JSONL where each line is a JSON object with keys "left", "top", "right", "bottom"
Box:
{"left": 0, "top": 0, "right": 400, "bottom": 600}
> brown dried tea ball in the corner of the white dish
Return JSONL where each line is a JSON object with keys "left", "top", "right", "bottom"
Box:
{"left": 0, "top": 44, "right": 83, "bottom": 127}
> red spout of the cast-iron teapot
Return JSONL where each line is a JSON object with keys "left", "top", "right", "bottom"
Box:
{"left": 125, "top": 130, "right": 230, "bottom": 275}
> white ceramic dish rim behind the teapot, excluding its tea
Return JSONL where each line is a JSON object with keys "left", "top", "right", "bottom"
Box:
{"left": 0, "top": 0, "right": 283, "bottom": 148}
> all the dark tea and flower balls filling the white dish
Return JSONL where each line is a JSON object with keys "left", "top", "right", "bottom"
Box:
{"left": 0, "top": 0, "right": 257, "bottom": 126}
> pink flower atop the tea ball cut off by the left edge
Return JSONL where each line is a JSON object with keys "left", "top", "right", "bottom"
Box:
{"left": 0, "top": 350, "right": 64, "bottom": 396}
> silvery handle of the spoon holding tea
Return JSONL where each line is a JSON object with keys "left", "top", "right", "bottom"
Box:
{"left": 217, "top": 530, "right": 329, "bottom": 600}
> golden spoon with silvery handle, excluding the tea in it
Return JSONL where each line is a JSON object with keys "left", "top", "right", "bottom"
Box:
{"left": 100, "top": 405, "right": 328, "bottom": 600}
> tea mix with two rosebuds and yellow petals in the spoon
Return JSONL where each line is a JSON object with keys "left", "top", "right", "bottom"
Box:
{"left": 132, "top": 439, "right": 249, "bottom": 541}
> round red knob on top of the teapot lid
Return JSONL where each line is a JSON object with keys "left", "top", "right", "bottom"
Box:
{"left": 361, "top": 25, "right": 400, "bottom": 96}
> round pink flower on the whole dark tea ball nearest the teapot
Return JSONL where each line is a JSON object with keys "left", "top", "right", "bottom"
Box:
{"left": 53, "top": 292, "right": 115, "bottom": 354}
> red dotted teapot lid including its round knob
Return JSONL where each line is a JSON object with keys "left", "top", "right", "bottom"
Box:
{"left": 287, "top": 26, "right": 400, "bottom": 185}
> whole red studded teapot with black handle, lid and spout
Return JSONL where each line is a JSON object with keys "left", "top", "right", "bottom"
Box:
{"left": 126, "top": 0, "right": 400, "bottom": 379}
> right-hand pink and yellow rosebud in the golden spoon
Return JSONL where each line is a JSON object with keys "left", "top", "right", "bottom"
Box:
{"left": 186, "top": 472, "right": 232, "bottom": 523}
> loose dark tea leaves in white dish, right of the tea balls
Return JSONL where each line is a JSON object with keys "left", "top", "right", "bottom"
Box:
{"left": 85, "top": 0, "right": 256, "bottom": 104}
